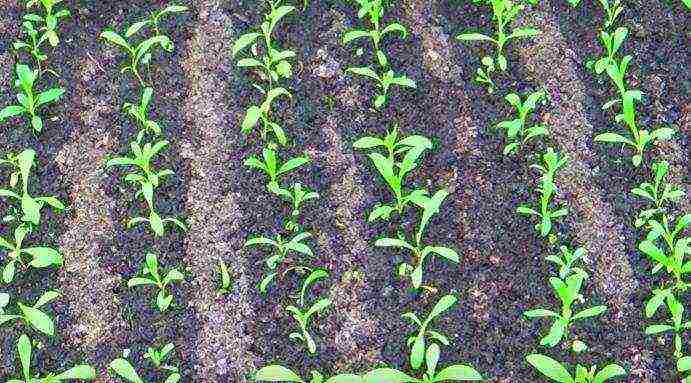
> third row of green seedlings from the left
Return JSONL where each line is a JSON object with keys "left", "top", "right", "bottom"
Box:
{"left": 232, "top": 0, "right": 331, "bottom": 355}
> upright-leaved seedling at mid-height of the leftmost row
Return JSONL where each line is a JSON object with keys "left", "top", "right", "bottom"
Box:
{"left": 0, "top": 149, "right": 65, "bottom": 228}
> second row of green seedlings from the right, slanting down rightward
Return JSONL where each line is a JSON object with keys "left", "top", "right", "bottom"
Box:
{"left": 457, "top": 0, "right": 626, "bottom": 383}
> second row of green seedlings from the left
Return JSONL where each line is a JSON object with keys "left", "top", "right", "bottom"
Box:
{"left": 100, "top": 5, "right": 187, "bottom": 383}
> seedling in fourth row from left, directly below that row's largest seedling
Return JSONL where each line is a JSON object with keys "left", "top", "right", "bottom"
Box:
{"left": 374, "top": 189, "right": 458, "bottom": 289}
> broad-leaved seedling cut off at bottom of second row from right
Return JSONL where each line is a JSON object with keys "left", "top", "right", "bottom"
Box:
{"left": 525, "top": 354, "right": 626, "bottom": 383}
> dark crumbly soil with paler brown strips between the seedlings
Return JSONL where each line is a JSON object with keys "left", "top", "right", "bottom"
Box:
{"left": 0, "top": 0, "right": 690, "bottom": 383}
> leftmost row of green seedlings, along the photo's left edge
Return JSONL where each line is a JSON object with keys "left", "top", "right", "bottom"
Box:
{"left": 0, "top": 0, "right": 96, "bottom": 382}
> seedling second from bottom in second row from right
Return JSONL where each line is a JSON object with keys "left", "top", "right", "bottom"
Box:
{"left": 523, "top": 270, "right": 607, "bottom": 347}
